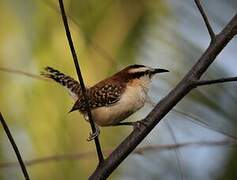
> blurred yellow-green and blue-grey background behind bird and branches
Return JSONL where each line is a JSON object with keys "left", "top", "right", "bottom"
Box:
{"left": 0, "top": 0, "right": 237, "bottom": 180}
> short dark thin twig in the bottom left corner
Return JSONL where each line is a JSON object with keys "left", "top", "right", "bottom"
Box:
{"left": 0, "top": 112, "right": 30, "bottom": 180}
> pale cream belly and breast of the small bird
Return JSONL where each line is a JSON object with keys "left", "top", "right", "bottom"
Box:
{"left": 92, "top": 87, "right": 147, "bottom": 126}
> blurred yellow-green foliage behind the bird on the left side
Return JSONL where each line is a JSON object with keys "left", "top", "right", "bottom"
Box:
{"left": 0, "top": 0, "right": 166, "bottom": 180}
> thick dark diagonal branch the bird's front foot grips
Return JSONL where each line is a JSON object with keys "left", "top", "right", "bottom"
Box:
{"left": 89, "top": 11, "right": 237, "bottom": 180}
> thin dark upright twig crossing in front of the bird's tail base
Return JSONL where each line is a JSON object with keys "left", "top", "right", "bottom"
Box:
{"left": 58, "top": 0, "right": 104, "bottom": 165}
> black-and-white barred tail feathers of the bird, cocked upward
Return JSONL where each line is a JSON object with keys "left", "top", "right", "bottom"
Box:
{"left": 41, "top": 67, "right": 81, "bottom": 99}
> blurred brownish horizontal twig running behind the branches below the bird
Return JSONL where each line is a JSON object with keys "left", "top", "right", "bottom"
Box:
{"left": 0, "top": 140, "right": 237, "bottom": 169}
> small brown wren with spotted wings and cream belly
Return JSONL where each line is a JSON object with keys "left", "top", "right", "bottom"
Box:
{"left": 41, "top": 64, "right": 169, "bottom": 140}
